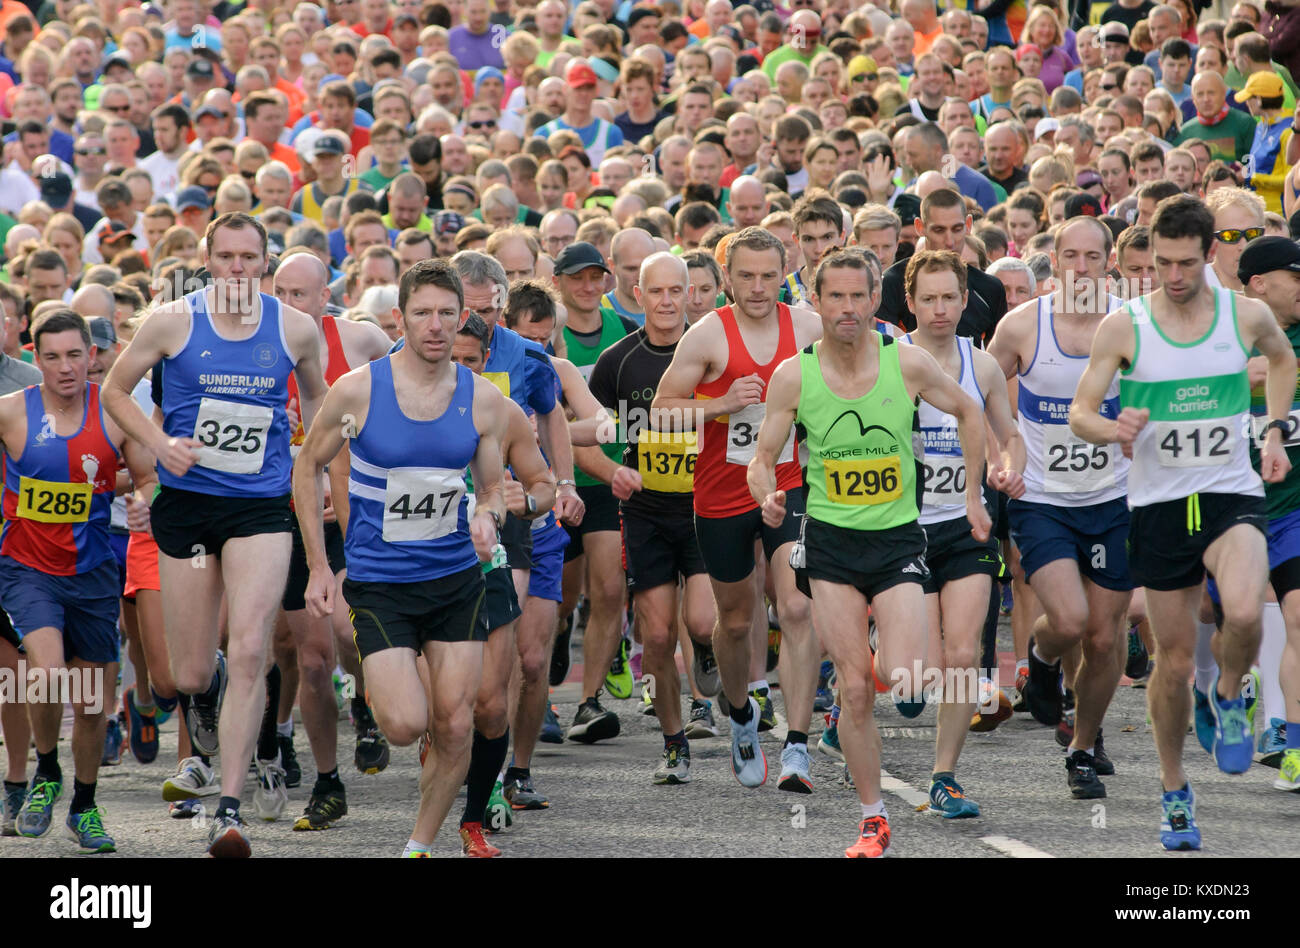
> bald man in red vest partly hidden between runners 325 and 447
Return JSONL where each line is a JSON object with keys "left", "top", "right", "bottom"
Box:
{"left": 274, "top": 251, "right": 391, "bottom": 830}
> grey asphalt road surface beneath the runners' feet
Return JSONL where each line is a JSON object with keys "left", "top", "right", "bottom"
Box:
{"left": 0, "top": 623, "right": 1300, "bottom": 860}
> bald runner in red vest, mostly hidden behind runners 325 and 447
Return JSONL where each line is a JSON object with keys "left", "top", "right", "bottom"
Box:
{"left": 273, "top": 251, "right": 391, "bottom": 830}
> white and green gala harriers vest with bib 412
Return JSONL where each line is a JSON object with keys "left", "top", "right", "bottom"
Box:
{"left": 1119, "top": 289, "right": 1264, "bottom": 507}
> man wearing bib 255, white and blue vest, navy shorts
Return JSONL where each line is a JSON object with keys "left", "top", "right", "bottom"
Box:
{"left": 988, "top": 217, "right": 1132, "bottom": 800}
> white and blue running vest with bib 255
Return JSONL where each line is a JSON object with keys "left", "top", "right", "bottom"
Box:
{"left": 1017, "top": 294, "right": 1128, "bottom": 507}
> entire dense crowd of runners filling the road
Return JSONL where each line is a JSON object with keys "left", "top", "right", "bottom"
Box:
{"left": 0, "top": 0, "right": 1300, "bottom": 857}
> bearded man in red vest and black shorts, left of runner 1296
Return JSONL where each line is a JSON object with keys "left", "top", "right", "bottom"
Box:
{"left": 653, "top": 228, "right": 822, "bottom": 793}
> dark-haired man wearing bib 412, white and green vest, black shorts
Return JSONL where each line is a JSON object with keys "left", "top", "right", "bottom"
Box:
{"left": 1070, "top": 195, "right": 1296, "bottom": 849}
